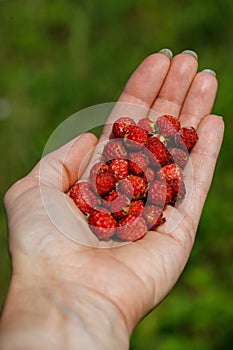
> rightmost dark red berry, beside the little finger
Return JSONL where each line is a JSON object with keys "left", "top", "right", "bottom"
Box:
{"left": 175, "top": 127, "right": 198, "bottom": 152}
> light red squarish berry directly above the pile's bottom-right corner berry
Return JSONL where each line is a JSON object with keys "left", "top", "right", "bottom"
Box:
{"left": 147, "top": 180, "right": 167, "bottom": 207}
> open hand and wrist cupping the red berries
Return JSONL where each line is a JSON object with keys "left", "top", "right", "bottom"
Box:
{"left": 0, "top": 53, "right": 224, "bottom": 350}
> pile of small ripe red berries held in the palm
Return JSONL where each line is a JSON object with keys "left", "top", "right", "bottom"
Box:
{"left": 69, "top": 115, "right": 198, "bottom": 241}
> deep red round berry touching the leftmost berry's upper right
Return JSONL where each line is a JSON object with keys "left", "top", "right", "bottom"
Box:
{"left": 92, "top": 171, "right": 116, "bottom": 196}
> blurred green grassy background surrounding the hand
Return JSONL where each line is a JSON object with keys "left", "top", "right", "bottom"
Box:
{"left": 0, "top": 0, "right": 233, "bottom": 350}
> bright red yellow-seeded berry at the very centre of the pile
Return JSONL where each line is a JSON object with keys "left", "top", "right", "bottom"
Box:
{"left": 118, "top": 175, "right": 147, "bottom": 199}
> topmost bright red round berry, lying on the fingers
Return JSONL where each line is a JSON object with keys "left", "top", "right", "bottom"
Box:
{"left": 155, "top": 115, "right": 181, "bottom": 137}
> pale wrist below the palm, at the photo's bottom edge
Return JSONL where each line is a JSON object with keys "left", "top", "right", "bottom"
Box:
{"left": 0, "top": 275, "right": 129, "bottom": 350}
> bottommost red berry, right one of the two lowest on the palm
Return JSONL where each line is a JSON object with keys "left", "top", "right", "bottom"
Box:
{"left": 116, "top": 214, "right": 147, "bottom": 241}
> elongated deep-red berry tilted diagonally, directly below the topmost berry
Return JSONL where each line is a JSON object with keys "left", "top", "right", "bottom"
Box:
{"left": 145, "top": 136, "right": 170, "bottom": 166}
